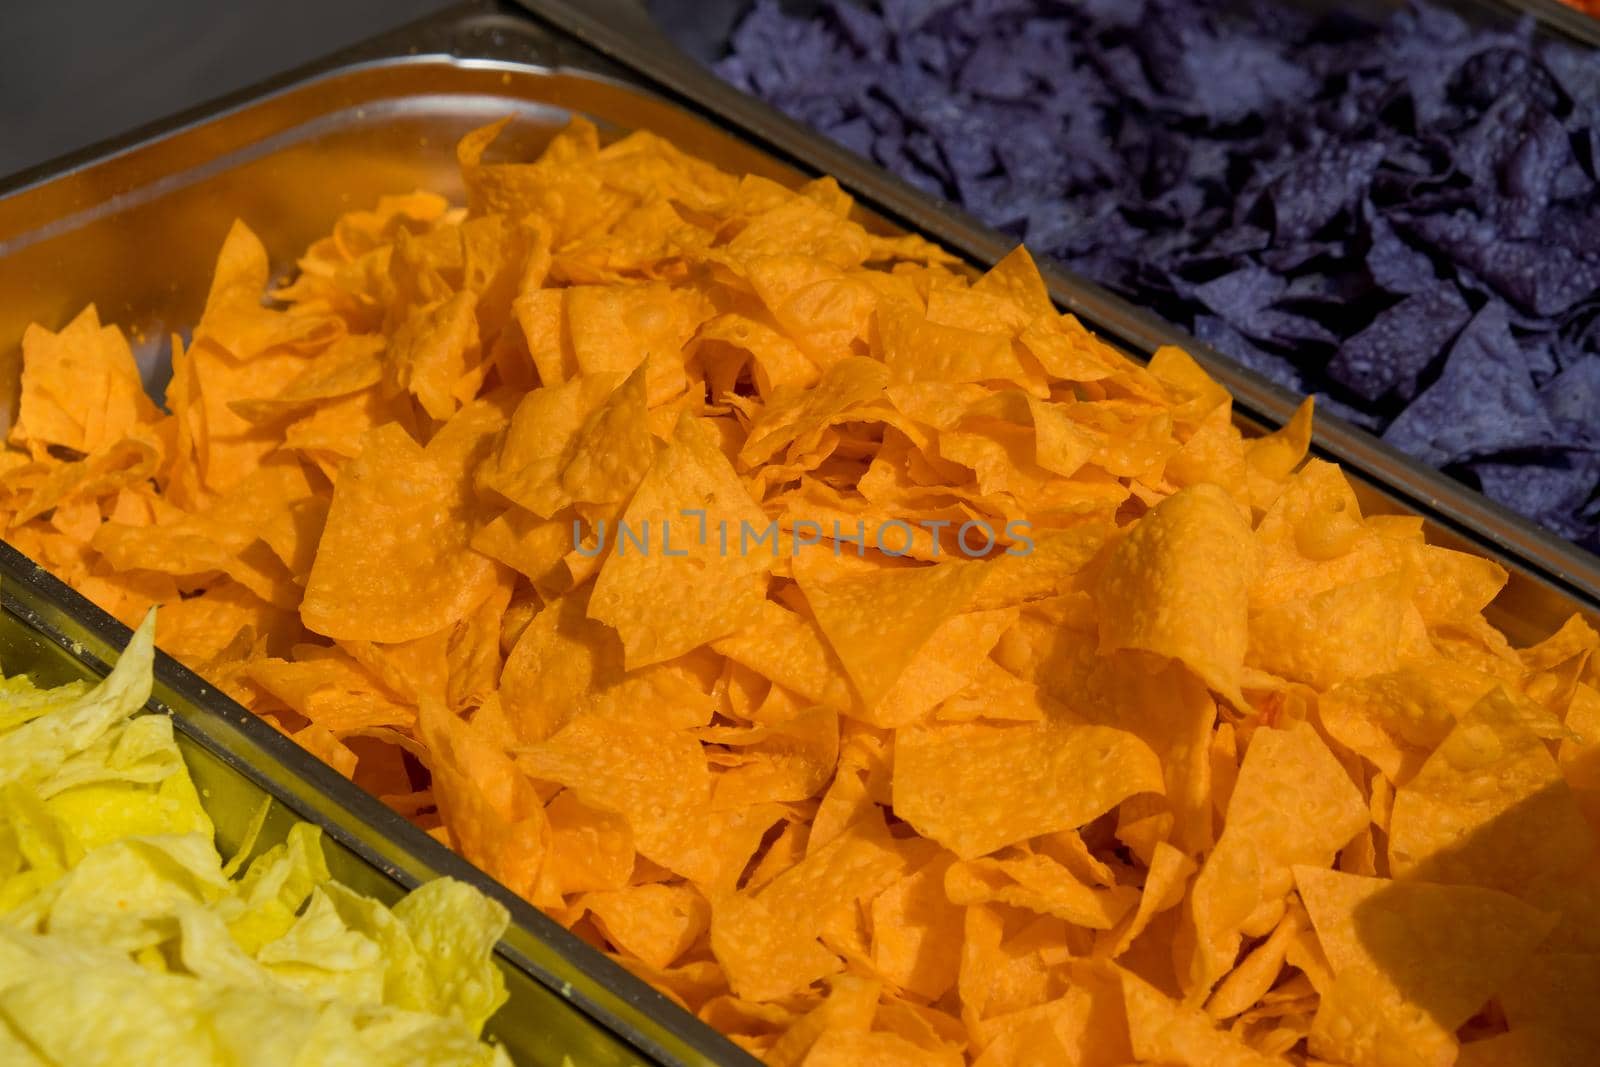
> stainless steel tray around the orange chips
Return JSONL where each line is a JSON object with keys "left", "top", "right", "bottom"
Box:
{"left": 0, "top": 0, "right": 1600, "bottom": 1064}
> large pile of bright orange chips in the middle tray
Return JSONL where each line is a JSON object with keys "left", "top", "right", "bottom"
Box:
{"left": 0, "top": 123, "right": 1600, "bottom": 1067}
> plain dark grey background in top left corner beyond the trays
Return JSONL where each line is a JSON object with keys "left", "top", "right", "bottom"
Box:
{"left": 0, "top": 0, "right": 451, "bottom": 176}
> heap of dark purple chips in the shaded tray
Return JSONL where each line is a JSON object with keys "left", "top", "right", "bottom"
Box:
{"left": 710, "top": 0, "right": 1600, "bottom": 550}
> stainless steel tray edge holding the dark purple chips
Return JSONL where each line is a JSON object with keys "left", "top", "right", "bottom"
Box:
{"left": 518, "top": 0, "right": 1600, "bottom": 640}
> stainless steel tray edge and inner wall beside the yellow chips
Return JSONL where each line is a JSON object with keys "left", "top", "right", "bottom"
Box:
{"left": 0, "top": 544, "right": 726, "bottom": 1067}
